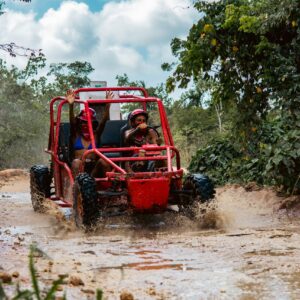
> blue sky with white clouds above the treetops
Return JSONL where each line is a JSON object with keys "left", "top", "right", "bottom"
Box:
{"left": 0, "top": 0, "right": 199, "bottom": 91}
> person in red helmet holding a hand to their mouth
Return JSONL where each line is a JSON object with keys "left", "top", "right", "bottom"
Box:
{"left": 124, "top": 109, "right": 161, "bottom": 172}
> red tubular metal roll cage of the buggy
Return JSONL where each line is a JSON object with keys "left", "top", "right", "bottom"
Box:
{"left": 46, "top": 87, "right": 183, "bottom": 206}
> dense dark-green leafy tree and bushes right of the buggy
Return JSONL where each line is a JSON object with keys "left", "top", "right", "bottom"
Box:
{"left": 163, "top": 0, "right": 300, "bottom": 193}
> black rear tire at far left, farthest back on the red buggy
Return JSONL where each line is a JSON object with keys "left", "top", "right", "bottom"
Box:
{"left": 30, "top": 165, "right": 51, "bottom": 212}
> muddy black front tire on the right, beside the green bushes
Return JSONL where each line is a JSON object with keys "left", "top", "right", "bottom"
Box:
{"left": 183, "top": 174, "right": 216, "bottom": 204}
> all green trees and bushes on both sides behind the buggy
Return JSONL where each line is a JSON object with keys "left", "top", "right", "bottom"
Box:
{"left": 0, "top": 0, "right": 300, "bottom": 194}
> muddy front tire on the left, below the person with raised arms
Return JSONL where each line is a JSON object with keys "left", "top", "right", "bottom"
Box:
{"left": 73, "top": 173, "right": 100, "bottom": 229}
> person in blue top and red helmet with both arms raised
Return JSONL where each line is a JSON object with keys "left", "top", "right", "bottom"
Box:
{"left": 66, "top": 90, "right": 113, "bottom": 177}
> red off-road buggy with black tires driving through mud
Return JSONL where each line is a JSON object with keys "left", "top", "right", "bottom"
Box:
{"left": 30, "top": 87, "right": 215, "bottom": 227}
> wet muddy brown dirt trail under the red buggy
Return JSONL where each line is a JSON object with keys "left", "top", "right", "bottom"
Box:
{"left": 0, "top": 171, "right": 300, "bottom": 299}
